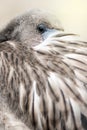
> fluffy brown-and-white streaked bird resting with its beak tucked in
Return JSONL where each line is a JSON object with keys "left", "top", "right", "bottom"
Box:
{"left": 0, "top": 9, "right": 87, "bottom": 130}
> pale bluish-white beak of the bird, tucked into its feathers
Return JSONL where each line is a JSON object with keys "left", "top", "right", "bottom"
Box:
{"left": 42, "top": 29, "right": 64, "bottom": 40}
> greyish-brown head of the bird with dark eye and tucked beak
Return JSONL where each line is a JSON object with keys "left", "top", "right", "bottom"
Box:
{"left": 0, "top": 9, "right": 63, "bottom": 47}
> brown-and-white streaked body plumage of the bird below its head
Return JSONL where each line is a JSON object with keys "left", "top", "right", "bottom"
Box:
{"left": 0, "top": 32, "right": 87, "bottom": 130}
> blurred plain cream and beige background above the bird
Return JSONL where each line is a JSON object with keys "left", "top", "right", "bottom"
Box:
{"left": 0, "top": 0, "right": 87, "bottom": 41}
